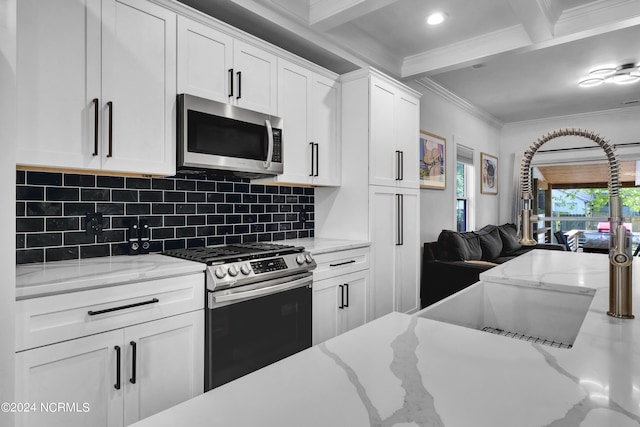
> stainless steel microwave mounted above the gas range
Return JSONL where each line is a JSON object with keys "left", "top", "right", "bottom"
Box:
{"left": 177, "top": 94, "right": 283, "bottom": 178}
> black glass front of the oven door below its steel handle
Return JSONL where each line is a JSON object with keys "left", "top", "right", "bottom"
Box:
{"left": 205, "top": 276, "right": 312, "bottom": 391}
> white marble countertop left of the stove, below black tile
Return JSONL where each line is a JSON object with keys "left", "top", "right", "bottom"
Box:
{"left": 16, "top": 254, "right": 205, "bottom": 300}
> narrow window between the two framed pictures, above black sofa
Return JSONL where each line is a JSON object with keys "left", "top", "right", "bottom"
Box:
{"left": 456, "top": 145, "right": 475, "bottom": 231}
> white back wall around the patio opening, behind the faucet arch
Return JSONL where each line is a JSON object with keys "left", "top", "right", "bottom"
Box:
{"left": 498, "top": 107, "right": 640, "bottom": 223}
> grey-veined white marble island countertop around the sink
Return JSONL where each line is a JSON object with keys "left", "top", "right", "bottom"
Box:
{"left": 129, "top": 251, "right": 640, "bottom": 427}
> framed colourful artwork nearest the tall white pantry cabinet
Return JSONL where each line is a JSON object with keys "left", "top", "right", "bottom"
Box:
{"left": 420, "top": 130, "right": 447, "bottom": 190}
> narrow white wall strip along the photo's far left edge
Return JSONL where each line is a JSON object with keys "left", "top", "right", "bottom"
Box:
{"left": 0, "top": 0, "right": 16, "bottom": 426}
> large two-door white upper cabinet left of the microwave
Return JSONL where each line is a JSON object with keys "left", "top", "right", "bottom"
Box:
{"left": 17, "top": 0, "right": 176, "bottom": 175}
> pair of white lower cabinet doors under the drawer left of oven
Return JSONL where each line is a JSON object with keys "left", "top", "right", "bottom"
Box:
{"left": 16, "top": 310, "right": 204, "bottom": 427}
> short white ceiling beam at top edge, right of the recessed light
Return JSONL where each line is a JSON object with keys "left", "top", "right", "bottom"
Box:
{"left": 508, "top": 0, "right": 560, "bottom": 43}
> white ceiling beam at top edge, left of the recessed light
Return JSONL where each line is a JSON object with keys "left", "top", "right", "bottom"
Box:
{"left": 309, "top": 0, "right": 398, "bottom": 31}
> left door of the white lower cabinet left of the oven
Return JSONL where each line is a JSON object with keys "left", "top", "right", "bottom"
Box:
{"left": 16, "top": 330, "right": 124, "bottom": 427}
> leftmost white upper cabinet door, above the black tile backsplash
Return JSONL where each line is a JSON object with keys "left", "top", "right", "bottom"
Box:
{"left": 16, "top": 0, "right": 102, "bottom": 169}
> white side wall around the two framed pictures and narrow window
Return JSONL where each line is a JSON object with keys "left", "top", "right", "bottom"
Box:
{"left": 408, "top": 82, "right": 503, "bottom": 243}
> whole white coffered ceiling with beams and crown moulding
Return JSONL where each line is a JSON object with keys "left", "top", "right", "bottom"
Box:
{"left": 181, "top": 0, "right": 640, "bottom": 123}
